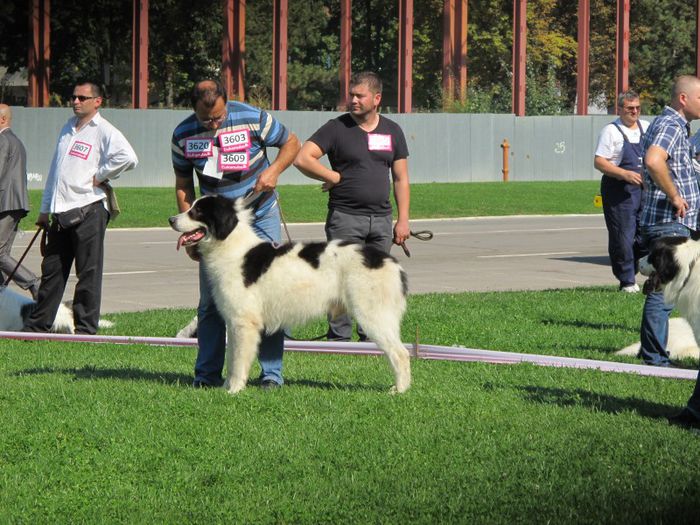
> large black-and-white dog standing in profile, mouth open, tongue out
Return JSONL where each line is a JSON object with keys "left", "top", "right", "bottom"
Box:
{"left": 170, "top": 196, "right": 411, "bottom": 394}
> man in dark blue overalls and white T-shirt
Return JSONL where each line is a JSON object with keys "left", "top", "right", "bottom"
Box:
{"left": 593, "top": 91, "right": 649, "bottom": 293}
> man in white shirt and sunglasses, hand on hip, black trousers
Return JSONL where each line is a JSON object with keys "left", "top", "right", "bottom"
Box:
{"left": 24, "top": 82, "right": 138, "bottom": 334}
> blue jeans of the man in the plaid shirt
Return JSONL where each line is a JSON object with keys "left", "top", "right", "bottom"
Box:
{"left": 639, "top": 222, "right": 690, "bottom": 366}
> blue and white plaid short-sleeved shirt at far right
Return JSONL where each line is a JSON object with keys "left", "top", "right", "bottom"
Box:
{"left": 640, "top": 106, "right": 700, "bottom": 230}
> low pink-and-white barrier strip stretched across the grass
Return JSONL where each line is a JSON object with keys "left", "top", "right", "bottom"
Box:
{"left": 0, "top": 331, "right": 698, "bottom": 380}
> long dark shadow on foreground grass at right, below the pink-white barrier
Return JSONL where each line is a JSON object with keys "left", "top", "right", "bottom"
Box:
{"left": 517, "top": 386, "right": 680, "bottom": 419}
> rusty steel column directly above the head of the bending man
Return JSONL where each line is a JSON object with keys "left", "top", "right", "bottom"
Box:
{"left": 221, "top": 0, "right": 245, "bottom": 100}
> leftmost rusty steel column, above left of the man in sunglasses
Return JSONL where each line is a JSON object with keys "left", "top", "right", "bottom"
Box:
{"left": 27, "top": 0, "right": 51, "bottom": 108}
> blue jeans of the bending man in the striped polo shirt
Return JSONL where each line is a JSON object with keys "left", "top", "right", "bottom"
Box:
{"left": 194, "top": 202, "right": 284, "bottom": 386}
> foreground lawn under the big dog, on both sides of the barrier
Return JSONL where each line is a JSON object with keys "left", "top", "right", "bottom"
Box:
{"left": 0, "top": 287, "right": 700, "bottom": 524}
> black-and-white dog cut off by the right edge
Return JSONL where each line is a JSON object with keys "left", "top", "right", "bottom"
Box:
{"left": 639, "top": 237, "right": 700, "bottom": 357}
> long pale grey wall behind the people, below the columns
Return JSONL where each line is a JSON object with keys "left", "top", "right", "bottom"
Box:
{"left": 12, "top": 107, "right": 698, "bottom": 189}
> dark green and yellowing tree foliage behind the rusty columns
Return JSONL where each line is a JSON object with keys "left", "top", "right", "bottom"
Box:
{"left": 0, "top": 0, "right": 696, "bottom": 114}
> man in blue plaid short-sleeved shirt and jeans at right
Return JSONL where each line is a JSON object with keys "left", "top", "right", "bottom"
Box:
{"left": 640, "top": 75, "right": 700, "bottom": 366}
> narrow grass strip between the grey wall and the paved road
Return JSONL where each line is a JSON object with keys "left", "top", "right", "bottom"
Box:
{"left": 28, "top": 181, "right": 602, "bottom": 229}
